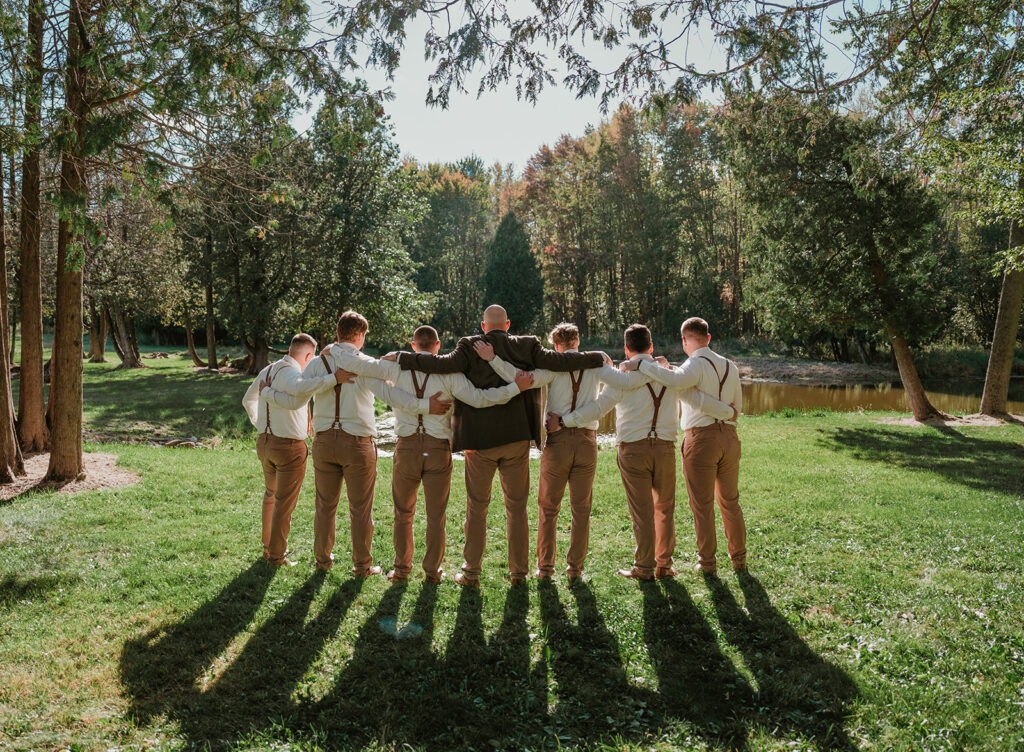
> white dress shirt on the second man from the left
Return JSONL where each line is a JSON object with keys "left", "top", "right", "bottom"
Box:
{"left": 266, "top": 342, "right": 430, "bottom": 437}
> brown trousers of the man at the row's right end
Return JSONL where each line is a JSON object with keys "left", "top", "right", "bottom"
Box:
{"left": 683, "top": 423, "right": 746, "bottom": 572}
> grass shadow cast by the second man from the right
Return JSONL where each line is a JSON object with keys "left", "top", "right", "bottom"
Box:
{"left": 640, "top": 579, "right": 754, "bottom": 749}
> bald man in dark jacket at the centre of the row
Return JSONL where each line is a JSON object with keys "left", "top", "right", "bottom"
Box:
{"left": 398, "top": 305, "right": 604, "bottom": 587}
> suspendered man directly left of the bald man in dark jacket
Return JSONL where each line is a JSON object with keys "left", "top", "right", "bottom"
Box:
{"left": 329, "top": 326, "right": 540, "bottom": 583}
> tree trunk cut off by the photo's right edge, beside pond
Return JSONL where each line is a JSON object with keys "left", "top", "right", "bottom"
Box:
{"left": 979, "top": 215, "right": 1024, "bottom": 422}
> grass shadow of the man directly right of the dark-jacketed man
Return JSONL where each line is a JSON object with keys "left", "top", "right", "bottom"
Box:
{"left": 537, "top": 580, "right": 662, "bottom": 744}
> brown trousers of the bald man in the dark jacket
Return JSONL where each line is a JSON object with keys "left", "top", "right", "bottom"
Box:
{"left": 462, "top": 441, "right": 529, "bottom": 577}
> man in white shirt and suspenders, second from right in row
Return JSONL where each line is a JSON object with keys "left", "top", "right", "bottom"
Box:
{"left": 548, "top": 324, "right": 734, "bottom": 581}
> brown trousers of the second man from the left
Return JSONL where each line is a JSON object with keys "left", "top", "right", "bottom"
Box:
{"left": 313, "top": 428, "right": 377, "bottom": 573}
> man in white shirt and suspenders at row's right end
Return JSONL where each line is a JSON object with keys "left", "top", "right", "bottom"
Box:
{"left": 622, "top": 318, "right": 746, "bottom": 575}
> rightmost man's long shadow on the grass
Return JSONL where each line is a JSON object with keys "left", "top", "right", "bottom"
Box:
{"left": 708, "top": 572, "right": 858, "bottom": 750}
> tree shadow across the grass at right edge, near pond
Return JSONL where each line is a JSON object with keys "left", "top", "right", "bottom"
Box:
{"left": 820, "top": 426, "right": 1024, "bottom": 495}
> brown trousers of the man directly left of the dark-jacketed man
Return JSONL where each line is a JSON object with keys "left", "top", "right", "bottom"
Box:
{"left": 391, "top": 433, "right": 452, "bottom": 577}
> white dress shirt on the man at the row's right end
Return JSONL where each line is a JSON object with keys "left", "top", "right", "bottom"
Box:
{"left": 640, "top": 347, "right": 743, "bottom": 429}
